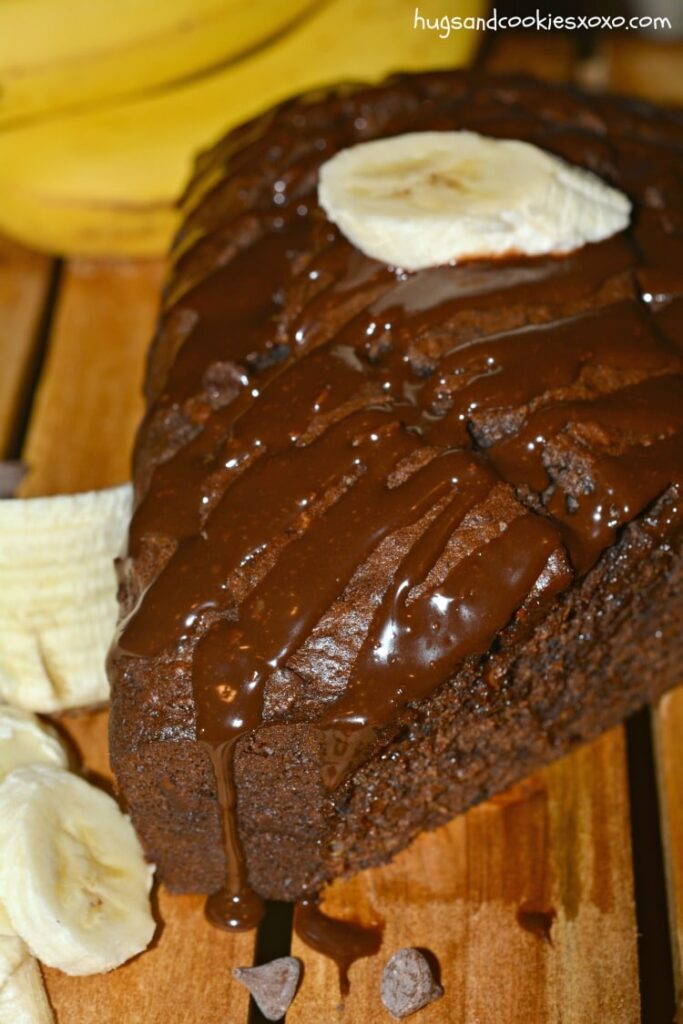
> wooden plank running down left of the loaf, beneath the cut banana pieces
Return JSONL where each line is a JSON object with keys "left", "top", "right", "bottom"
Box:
{"left": 15, "top": 262, "right": 254, "bottom": 1024}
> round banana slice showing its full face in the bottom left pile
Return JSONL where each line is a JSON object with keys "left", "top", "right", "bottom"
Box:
{"left": 0, "top": 765, "right": 155, "bottom": 975}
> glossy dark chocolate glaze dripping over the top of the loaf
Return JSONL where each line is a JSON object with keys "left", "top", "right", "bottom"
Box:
{"left": 114, "top": 74, "right": 683, "bottom": 928}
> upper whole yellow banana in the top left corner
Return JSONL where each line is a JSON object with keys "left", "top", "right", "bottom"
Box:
{"left": 0, "top": 0, "right": 315, "bottom": 127}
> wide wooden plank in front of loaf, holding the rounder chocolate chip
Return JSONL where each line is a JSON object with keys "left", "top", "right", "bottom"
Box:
{"left": 287, "top": 729, "right": 640, "bottom": 1024}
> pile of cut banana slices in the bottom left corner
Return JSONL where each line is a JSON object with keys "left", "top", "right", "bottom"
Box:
{"left": 0, "top": 705, "right": 155, "bottom": 1024}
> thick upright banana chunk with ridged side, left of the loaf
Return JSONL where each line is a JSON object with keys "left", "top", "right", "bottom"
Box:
{"left": 0, "top": 484, "right": 132, "bottom": 713}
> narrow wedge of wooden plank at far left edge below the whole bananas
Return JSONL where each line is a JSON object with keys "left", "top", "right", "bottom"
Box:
{"left": 0, "top": 238, "right": 52, "bottom": 458}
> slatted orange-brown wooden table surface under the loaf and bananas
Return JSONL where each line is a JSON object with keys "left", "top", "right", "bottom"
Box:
{"left": 0, "top": 34, "right": 683, "bottom": 1024}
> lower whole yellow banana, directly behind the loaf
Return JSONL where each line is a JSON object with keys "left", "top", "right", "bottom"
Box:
{"left": 0, "top": 0, "right": 481, "bottom": 256}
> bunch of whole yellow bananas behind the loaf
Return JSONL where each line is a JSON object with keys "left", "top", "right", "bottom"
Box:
{"left": 0, "top": 0, "right": 482, "bottom": 256}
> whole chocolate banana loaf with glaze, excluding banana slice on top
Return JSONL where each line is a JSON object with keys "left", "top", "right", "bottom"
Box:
{"left": 110, "top": 73, "right": 683, "bottom": 926}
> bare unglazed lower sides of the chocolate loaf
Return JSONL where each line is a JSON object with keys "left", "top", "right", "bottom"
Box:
{"left": 111, "top": 488, "right": 683, "bottom": 900}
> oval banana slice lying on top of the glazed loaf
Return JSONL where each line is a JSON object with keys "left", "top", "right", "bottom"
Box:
{"left": 318, "top": 131, "right": 631, "bottom": 270}
